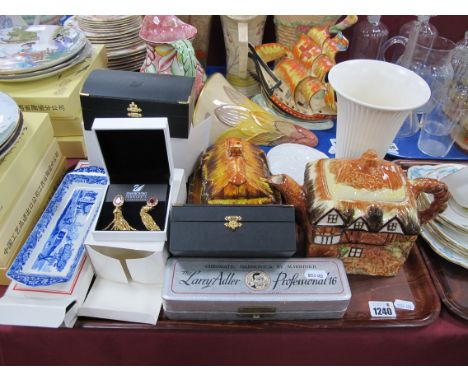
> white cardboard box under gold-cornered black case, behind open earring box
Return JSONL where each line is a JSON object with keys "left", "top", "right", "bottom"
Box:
{"left": 83, "top": 117, "right": 212, "bottom": 177}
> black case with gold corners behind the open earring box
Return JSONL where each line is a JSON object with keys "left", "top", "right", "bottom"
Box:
{"left": 80, "top": 69, "right": 194, "bottom": 138}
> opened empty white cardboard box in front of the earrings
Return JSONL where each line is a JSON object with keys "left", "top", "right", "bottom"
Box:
{"left": 78, "top": 169, "right": 187, "bottom": 325}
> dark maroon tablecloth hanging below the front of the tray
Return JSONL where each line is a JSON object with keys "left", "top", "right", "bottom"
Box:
{"left": 0, "top": 287, "right": 468, "bottom": 365}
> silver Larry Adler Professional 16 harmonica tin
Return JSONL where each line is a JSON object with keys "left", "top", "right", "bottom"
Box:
{"left": 162, "top": 258, "right": 351, "bottom": 319}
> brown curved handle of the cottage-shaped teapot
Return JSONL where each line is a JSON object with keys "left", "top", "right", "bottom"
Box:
{"left": 411, "top": 178, "right": 450, "bottom": 224}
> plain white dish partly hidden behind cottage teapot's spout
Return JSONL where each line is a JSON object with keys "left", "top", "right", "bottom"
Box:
{"left": 267, "top": 143, "right": 328, "bottom": 185}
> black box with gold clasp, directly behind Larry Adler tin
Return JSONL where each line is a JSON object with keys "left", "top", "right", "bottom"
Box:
{"left": 169, "top": 204, "right": 296, "bottom": 258}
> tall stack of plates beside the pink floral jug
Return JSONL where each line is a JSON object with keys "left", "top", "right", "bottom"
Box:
{"left": 72, "top": 16, "right": 146, "bottom": 71}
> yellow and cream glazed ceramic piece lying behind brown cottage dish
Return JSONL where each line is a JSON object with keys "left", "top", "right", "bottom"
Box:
{"left": 193, "top": 73, "right": 318, "bottom": 147}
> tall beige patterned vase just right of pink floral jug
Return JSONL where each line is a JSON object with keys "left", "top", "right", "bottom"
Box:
{"left": 221, "top": 16, "right": 266, "bottom": 97}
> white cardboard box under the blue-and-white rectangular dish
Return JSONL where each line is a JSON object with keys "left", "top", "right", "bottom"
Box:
{"left": 0, "top": 256, "right": 94, "bottom": 328}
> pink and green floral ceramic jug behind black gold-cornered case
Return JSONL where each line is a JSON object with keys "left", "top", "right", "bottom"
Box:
{"left": 140, "top": 16, "right": 206, "bottom": 97}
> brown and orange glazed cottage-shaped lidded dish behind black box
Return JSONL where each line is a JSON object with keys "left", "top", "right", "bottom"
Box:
{"left": 188, "top": 138, "right": 281, "bottom": 204}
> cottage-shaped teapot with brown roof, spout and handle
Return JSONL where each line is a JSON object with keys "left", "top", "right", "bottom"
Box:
{"left": 269, "top": 150, "right": 449, "bottom": 276}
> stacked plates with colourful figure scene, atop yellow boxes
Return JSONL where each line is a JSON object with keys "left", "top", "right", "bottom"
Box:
{"left": 0, "top": 25, "right": 91, "bottom": 81}
